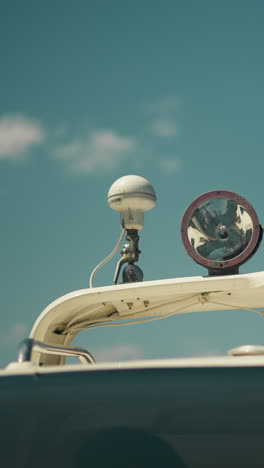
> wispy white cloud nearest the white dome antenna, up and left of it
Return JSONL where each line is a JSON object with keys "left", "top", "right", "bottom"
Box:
{"left": 53, "top": 130, "right": 137, "bottom": 172}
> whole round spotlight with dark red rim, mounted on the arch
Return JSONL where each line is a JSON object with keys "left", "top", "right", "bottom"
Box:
{"left": 181, "top": 190, "right": 262, "bottom": 274}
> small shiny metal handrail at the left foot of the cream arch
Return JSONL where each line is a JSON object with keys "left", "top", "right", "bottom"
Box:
{"left": 17, "top": 338, "right": 95, "bottom": 364}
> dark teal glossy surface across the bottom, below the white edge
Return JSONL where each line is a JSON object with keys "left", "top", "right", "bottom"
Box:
{"left": 0, "top": 368, "right": 264, "bottom": 468}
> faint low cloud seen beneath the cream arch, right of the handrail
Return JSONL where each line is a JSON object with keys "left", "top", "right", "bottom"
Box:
{"left": 93, "top": 344, "right": 144, "bottom": 362}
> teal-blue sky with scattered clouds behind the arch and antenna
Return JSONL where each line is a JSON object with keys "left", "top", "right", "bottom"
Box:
{"left": 0, "top": 0, "right": 264, "bottom": 365}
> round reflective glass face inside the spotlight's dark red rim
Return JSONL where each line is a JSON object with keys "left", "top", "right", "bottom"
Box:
{"left": 187, "top": 197, "right": 253, "bottom": 262}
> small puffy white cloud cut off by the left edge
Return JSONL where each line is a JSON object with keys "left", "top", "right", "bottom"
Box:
{"left": 0, "top": 115, "right": 45, "bottom": 159}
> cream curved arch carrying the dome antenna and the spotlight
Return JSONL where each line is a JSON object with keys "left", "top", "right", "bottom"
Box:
{"left": 27, "top": 272, "right": 264, "bottom": 364}
